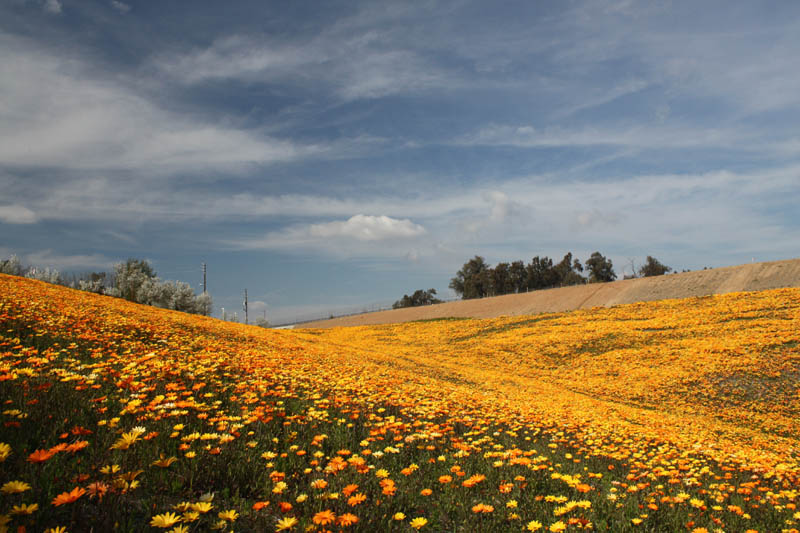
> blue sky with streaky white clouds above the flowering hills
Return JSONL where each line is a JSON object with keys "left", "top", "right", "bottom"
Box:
{"left": 0, "top": 0, "right": 800, "bottom": 323}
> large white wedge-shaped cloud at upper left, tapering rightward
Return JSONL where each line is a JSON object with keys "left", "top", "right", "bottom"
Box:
{"left": 0, "top": 35, "right": 328, "bottom": 173}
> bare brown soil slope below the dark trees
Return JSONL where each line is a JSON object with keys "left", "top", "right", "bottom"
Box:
{"left": 301, "top": 259, "right": 800, "bottom": 328}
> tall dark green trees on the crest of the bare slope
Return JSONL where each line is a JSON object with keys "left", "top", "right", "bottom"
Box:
{"left": 449, "top": 252, "right": 672, "bottom": 300}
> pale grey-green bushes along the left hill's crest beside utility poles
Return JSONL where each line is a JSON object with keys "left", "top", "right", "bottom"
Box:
{"left": 0, "top": 255, "right": 213, "bottom": 316}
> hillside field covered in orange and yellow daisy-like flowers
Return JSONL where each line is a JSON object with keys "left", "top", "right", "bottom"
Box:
{"left": 0, "top": 275, "right": 800, "bottom": 533}
